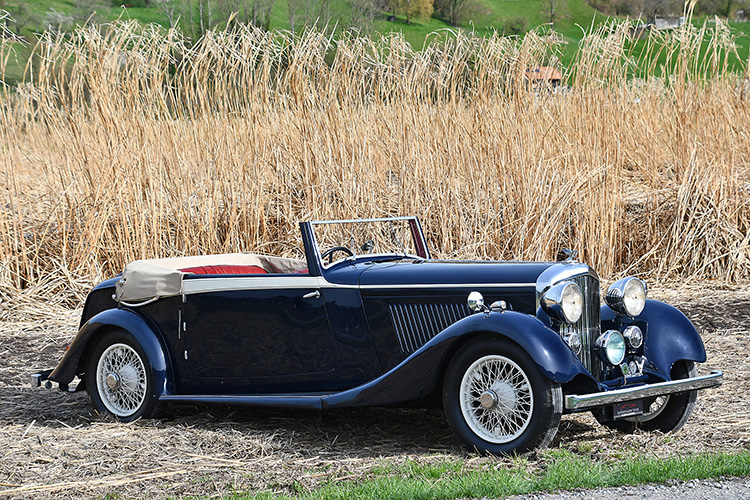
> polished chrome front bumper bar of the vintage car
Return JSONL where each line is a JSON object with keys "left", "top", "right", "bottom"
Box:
{"left": 565, "top": 371, "right": 724, "bottom": 411}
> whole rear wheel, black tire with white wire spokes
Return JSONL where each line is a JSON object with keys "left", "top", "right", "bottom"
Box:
{"left": 86, "top": 330, "right": 159, "bottom": 422}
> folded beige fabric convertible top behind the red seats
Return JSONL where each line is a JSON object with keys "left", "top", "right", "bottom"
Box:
{"left": 115, "top": 253, "right": 307, "bottom": 305}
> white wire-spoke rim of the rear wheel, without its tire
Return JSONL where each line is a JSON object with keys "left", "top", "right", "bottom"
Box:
{"left": 96, "top": 343, "right": 147, "bottom": 417}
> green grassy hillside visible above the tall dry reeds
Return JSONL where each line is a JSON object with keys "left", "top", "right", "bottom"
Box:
{"left": 0, "top": 0, "right": 750, "bottom": 85}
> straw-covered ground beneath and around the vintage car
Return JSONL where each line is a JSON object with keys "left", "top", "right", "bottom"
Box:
{"left": 0, "top": 285, "right": 750, "bottom": 499}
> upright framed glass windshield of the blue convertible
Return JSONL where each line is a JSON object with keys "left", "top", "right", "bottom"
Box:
{"left": 312, "top": 217, "right": 429, "bottom": 267}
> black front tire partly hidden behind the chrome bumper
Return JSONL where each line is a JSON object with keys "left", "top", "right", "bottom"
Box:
{"left": 597, "top": 361, "right": 698, "bottom": 434}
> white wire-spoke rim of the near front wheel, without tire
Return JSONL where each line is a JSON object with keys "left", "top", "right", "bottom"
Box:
{"left": 459, "top": 355, "right": 534, "bottom": 444}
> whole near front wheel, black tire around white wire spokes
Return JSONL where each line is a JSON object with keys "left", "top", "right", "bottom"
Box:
{"left": 443, "top": 339, "right": 563, "bottom": 455}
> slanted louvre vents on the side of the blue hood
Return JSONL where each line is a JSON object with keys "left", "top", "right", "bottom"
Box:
{"left": 388, "top": 303, "right": 471, "bottom": 354}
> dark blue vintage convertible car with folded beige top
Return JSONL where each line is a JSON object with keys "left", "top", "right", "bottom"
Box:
{"left": 32, "top": 217, "right": 722, "bottom": 453}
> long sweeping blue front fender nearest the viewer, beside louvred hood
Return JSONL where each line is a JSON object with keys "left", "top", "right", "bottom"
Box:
{"left": 323, "top": 311, "right": 593, "bottom": 408}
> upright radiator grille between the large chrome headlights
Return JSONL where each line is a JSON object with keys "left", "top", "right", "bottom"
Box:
{"left": 560, "top": 274, "right": 602, "bottom": 379}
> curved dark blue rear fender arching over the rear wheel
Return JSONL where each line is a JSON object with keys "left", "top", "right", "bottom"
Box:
{"left": 49, "top": 309, "right": 172, "bottom": 397}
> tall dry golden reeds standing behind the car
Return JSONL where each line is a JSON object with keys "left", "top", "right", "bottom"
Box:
{"left": 0, "top": 22, "right": 750, "bottom": 302}
